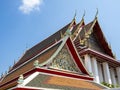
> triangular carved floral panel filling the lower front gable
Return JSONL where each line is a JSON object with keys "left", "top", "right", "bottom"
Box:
{"left": 50, "top": 46, "right": 80, "bottom": 72}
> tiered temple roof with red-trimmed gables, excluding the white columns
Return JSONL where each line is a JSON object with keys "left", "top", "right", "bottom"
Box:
{"left": 0, "top": 15, "right": 120, "bottom": 90}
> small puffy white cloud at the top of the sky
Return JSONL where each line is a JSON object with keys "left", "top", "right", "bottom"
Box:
{"left": 19, "top": 0, "right": 43, "bottom": 14}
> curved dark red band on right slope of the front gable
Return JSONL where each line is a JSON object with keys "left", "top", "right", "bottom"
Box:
{"left": 67, "top": 38, "right": 89, "bottom": 75}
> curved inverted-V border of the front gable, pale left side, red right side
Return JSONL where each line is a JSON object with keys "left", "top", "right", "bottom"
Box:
{"left": 40, "top": 36, "right": 89, "bottom": 75}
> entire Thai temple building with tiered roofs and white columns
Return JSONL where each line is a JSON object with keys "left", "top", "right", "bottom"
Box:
{"left": 0, "top": 13, "right": 120, "bottom": 90}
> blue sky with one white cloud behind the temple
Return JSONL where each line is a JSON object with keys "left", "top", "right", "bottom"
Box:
{"left": 0, "top": 0, "right": 120, "bottom": 73}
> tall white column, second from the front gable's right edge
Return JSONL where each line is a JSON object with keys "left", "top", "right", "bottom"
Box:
{"left": 91, "top": 57, "right": 100, "bottom": 83}
